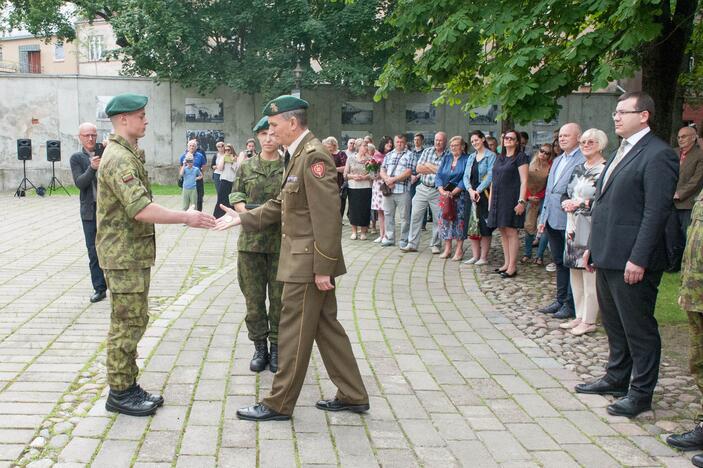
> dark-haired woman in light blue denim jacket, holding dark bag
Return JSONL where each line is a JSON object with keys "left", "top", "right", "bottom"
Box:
{"left": 464, "top": 130, "right": 496, "bottom": 265}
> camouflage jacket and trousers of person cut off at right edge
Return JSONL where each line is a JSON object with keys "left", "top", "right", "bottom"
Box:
{"left": 679, "top": 192, "right": 703, "bottom": 422}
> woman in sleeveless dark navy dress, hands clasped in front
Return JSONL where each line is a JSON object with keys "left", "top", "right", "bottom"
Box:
{"left": 487, "top": 130, "right": 528, "bottom": 278}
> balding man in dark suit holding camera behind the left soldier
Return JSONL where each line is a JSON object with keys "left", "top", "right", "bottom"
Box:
{"left": 70, "top": 122, "right": 107, "bottom": 302}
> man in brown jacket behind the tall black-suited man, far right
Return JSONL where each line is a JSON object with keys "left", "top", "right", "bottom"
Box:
{"left": 672, "top": 127, "right": 703, "bottom": 271}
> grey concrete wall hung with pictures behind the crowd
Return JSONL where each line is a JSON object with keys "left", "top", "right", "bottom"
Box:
{"left": 0, "top": 74, "right": 615, "bottom": 191}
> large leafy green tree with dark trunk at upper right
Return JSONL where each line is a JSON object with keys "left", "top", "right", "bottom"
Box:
{"left": 377, "top": 0, "right": 698, "bottom": 140}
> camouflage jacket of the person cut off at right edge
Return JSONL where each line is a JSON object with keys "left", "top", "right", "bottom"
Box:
{"left": 679, "top": 192, "right": 703, "bottom": 313}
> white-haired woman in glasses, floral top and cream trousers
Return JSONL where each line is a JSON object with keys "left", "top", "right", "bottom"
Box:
{"left": 560, "top": 128, "right": 608, "bottom": 336}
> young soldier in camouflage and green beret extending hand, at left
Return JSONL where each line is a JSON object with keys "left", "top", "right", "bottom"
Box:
{"left": 96, "top": 94, "right": 215, "bottom": 416}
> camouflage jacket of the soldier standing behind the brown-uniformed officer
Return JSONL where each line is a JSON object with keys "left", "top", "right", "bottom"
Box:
{"left": 229, "top": 155, "right": 283, "bottom": 253}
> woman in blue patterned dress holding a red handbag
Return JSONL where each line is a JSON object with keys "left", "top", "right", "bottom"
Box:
{"left": 435, "top": 136, "right": 468, "bottom": 262}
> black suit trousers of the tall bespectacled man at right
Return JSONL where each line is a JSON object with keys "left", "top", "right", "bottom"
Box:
{"left": 596, "top": 268, "right": 662, "bottom": 398}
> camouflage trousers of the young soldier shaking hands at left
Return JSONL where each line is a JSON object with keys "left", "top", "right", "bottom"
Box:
{"left": 105, "top": 268, "right": 151, "bottom": 391}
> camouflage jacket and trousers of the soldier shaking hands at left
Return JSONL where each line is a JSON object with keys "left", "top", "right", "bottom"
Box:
{"left": 95, "top": 135, "right": 156, "bottom": 391}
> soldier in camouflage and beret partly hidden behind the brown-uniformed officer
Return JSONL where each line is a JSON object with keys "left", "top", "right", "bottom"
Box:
{"left": 229, "top": 116, "right": 283, "bottom": 373}
